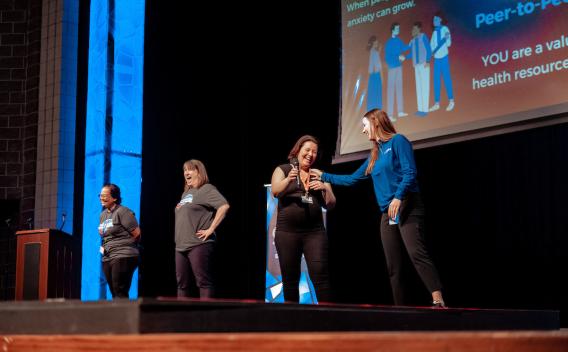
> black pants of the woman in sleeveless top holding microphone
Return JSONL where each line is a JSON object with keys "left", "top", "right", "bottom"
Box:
{"left": 274, "top": 230, "right": 331, "bottom": 303}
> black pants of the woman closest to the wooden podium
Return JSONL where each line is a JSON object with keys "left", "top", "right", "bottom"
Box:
{"left": 103, "top": 257, "right": 138, "bottom": 298}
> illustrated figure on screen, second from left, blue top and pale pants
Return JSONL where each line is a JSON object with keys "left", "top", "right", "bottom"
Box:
{"left": 385, "top": 22, "right": 410, "bottom": 121}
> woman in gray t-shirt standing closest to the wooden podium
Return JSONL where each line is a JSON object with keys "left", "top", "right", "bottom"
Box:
{"left": 99, "top": 183, "right": 140, "bottom": 298}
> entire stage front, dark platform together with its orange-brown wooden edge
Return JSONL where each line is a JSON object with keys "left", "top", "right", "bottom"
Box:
{"left": 0, "top": 299, "right": 568, "bottom": 352}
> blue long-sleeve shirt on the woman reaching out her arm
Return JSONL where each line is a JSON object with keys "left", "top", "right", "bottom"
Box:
{"left": 321, "top": 134, "right": 418, "bottom": 212}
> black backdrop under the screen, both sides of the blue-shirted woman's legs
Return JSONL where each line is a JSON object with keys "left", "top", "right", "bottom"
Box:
{"left": 330, "top": 124, "right": 568, "bottom": 314}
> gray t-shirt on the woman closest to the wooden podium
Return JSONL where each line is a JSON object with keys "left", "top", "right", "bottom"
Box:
{"left": 99, "top": 205, "right": 139, "bottom": 262}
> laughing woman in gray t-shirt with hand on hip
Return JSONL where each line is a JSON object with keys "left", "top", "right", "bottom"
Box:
{"left": 175, "top": 159, "right": 229, "bottom": 299}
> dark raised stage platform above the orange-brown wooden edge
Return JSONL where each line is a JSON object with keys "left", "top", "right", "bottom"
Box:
{"left": 0, "top": 299, "right": 560, "bottom": 334}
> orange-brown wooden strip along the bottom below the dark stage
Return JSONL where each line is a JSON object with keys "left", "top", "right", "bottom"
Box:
{"left": 1, "top": 331, "right": 568, "bottom": 352}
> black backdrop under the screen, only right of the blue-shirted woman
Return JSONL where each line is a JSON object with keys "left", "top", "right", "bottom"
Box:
{"left": 416, "top": 124, "right": 568, "bottom": 310}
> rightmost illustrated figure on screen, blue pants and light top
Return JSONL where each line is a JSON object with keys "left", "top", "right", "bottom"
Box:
{"left": 430, "top": 11, "right": 454, "bottom": 111}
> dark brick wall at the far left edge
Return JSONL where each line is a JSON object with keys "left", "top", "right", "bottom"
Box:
{"left": 0, "top": 0, "right": 41, "bottom": 300}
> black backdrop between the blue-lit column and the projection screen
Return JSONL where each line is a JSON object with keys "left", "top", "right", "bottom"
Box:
{"left": 141, "top": 1, "right": 339, "bottom": 299}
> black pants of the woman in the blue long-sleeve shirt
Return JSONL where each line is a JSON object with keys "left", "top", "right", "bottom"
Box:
{"left": 381, "top": 193, "right": 442, "bottom": 305}
